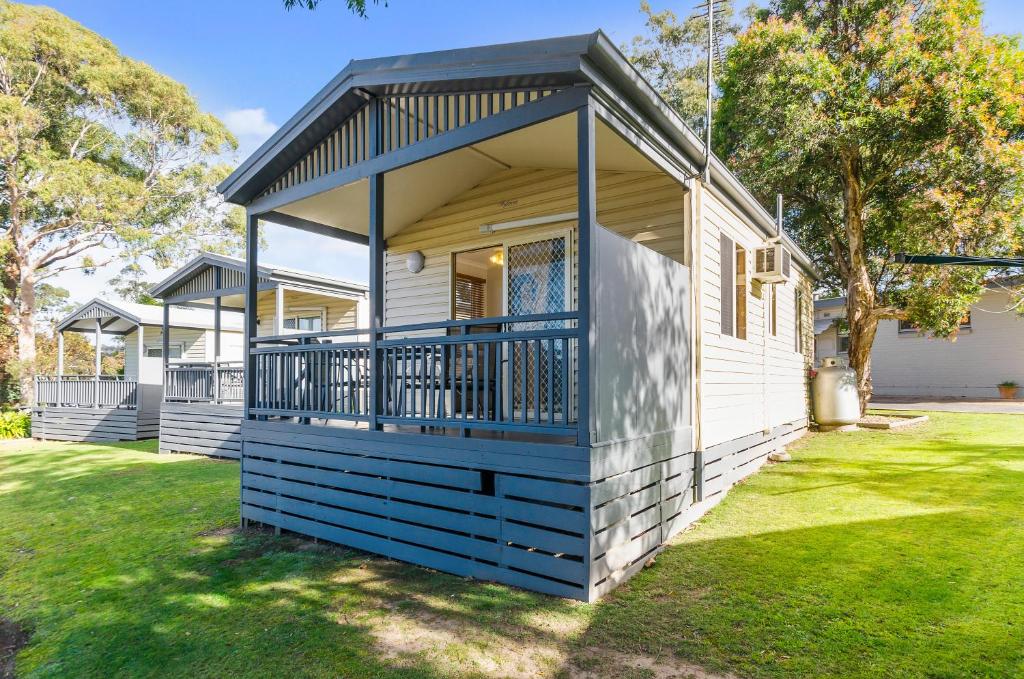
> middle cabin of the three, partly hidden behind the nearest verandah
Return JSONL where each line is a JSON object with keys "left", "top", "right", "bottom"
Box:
{"left": 150, "top": 252, "right": 369, "bottom": 459}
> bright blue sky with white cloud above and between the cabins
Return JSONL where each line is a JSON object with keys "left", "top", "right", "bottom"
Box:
{"left": 37, "top": 0, "right": 1024, "bottom": 301}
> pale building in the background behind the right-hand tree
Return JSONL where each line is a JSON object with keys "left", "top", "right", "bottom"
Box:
{"left": 814, "top": 279, "right": 1024, "bottom": 398}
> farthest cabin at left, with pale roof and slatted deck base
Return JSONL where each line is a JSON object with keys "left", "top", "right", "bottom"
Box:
{"left": 32, "top": 299, "right": 243, "bottom": 441}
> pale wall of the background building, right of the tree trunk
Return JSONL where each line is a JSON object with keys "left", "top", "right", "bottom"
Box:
{"left": 871, "top": 290, "right": 1024, "bottom": 398}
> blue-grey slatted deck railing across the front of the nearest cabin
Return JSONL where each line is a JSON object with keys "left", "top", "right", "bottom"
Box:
{"left": 250, "top": 312, "right": 579, "bottom": 434}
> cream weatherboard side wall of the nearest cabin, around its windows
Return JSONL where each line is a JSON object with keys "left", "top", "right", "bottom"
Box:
{"left": 700, "top": 190, "right": 807, "bottom": 449}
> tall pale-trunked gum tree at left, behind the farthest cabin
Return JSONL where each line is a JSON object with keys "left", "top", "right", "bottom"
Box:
{"left": 0, "top": 0, "right": 242, "bottom": 400}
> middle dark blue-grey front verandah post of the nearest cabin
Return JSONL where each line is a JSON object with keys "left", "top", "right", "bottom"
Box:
{"left": 369, "top": 98, "right": 384, "bottom": 430}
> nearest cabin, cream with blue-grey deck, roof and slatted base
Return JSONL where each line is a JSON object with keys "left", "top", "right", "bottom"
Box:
{"left": 219, "top": 32, "right": 815, "bottom": 601}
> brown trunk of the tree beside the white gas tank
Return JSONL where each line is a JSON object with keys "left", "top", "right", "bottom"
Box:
{"left": 843, "top": 150, "right": 879, "bottom": 414}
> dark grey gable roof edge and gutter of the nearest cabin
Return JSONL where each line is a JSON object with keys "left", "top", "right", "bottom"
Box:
{"left": 218, "top": 31, "right": 817, "bottom": 275}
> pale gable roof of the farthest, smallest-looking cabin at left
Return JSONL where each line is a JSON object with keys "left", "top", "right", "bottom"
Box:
{"left": 56, "top": 297, "right": 243, "bottom": 333}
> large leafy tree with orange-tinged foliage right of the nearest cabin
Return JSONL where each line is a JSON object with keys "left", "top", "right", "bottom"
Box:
{"left": 715, "top": 0, "right": 1024, "bottom": 409}
